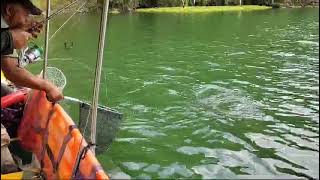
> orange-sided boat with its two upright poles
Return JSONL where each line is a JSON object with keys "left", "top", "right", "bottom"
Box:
{"left": 1, "top": 0, "right": 122, "bottom": 180}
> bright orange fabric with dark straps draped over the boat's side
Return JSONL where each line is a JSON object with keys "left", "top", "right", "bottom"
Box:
{"left": 18, "top": 91, "right": 109, "bottom": 179}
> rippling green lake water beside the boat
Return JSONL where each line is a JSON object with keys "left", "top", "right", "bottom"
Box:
{"left": 31, "top": 8, "right": 319, "bottom": 179}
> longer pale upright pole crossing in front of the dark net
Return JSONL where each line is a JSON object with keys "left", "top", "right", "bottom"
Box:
{"left": 90, "top": 0, "right": 109, "bottom": 154}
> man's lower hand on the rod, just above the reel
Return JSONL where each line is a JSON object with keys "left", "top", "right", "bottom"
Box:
{"left": 9, "top": 29, "right": 32, "bottom": 49}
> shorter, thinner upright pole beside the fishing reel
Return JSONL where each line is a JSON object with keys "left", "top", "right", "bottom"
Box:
{"left": 42, "top": 0, "right": 51, "bottom": 79}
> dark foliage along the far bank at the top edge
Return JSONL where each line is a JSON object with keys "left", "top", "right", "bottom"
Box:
{"left": 33, "top": 0, "right": 312, "bottom": 12}
